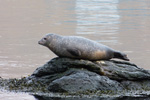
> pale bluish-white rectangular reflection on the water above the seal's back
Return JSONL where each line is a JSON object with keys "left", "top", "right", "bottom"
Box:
{"left": 75, "top": 0, "right": 120, "bottom": 35}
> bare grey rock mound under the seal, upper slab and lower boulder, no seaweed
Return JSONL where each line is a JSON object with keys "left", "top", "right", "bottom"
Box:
{"left": 28, "top": 58, "right": 150, "bottom": 93}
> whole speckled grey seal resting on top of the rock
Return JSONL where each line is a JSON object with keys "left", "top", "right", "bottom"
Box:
{"left": 38, "top": 33, "right": 129, "bottom": 61}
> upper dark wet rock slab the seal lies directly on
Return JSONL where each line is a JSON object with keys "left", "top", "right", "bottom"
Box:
{"left": 29, "top": 58, "right": 150, "bottom": 80}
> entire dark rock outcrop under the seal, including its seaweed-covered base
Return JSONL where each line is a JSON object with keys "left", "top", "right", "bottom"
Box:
{"left": 0, "top": 57, "right": 150, "bottom": 96}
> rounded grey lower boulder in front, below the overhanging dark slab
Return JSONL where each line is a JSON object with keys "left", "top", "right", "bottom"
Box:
{"left": 48, "top": 69, "right": 123, "bottom": 93}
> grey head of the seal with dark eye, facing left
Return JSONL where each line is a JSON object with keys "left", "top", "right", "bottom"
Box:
{"left": 38, "top": 33, "right": 55, "bottom": 46}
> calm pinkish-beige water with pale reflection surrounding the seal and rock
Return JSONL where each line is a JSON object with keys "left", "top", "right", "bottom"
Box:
{"left": 0, "top": 0, "right": 150, "bottom": 100}
